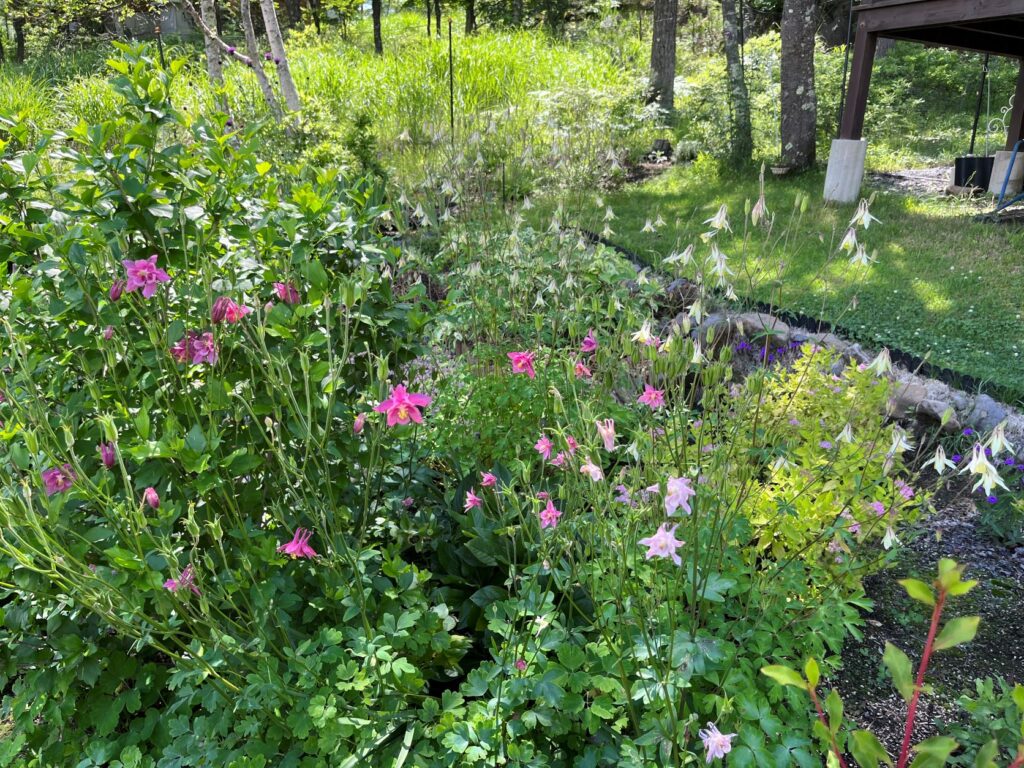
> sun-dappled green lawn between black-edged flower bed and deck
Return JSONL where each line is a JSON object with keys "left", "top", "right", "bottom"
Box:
{"left": 541, "top": 166, "right": 1024, "bottom": 399}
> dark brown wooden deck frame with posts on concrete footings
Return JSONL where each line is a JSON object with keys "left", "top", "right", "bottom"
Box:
{"left": 839, "top": 0, "right": 1024, "bottom": 150}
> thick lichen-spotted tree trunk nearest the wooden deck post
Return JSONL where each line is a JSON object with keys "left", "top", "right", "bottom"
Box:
{"left": 781, "top": 0, "right": 818, "bottom": 170}
